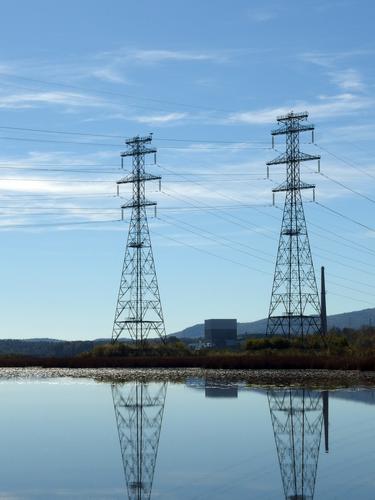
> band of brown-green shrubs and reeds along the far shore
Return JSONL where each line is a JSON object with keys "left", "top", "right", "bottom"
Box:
{"left": 0, "top": 327, "right": 375, "bottom": 371}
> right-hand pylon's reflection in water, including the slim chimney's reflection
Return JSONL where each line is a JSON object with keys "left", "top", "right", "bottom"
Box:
{"left": 268, "top": 389, "right": 328, "bottom": 500}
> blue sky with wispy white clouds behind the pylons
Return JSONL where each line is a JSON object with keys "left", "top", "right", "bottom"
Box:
{"left": 0, "top": 0, "right": 375, "bottom": 339}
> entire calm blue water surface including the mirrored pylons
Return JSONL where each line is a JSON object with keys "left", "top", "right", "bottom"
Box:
{"left": 0, "top": 378, "right": 375, "bottom": 500}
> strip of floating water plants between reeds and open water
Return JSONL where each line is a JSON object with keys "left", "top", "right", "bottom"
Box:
{"left": 0, "top": 366, "right": 375, "bottom": 389}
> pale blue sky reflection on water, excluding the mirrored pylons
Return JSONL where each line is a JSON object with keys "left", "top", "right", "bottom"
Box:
{"left": 0, "top": 379, "right": 375, "bottom": 500}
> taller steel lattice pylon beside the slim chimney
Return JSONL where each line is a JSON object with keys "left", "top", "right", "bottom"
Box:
{"left": 267, "top": 112, "right": 321, "bottom": 338}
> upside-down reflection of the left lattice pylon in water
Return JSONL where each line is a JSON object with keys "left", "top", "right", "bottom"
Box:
{"left": 112, "top": 382, "right": 167, "bottom": 500}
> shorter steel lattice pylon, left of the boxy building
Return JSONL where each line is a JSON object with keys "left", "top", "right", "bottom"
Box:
{"left": 112, "top": 134, "right": 165, "bottom": 344}
